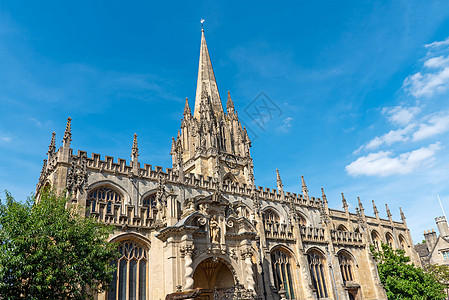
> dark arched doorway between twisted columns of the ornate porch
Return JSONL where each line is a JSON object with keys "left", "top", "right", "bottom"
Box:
{"left": 193, "top": 258, "right": 235, "bottom": 300}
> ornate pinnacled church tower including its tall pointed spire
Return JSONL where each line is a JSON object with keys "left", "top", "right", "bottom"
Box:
{"left": 170, "top": 29, "right": 254, "bottom": 185}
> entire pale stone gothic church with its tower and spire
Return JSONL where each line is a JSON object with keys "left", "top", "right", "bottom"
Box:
{"left": 37, "top": 28, "right": 419, "bottom": 299}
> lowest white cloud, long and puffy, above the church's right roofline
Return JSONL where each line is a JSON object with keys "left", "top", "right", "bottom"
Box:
{"left": 345, "top": 142, "right": 441, "bottom": 177}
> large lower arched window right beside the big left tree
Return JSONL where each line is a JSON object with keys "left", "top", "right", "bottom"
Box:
{"left": 107, "top": 240, "right": 147, "bottom": 300}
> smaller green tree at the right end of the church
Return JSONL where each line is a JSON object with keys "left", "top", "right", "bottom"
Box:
{"left": 371, "top": 244, "right": 445, "bottom": 300}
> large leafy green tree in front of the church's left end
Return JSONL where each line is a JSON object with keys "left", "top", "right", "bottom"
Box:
{"left": 0, "top": 190, "right": 117, "bottom": 299}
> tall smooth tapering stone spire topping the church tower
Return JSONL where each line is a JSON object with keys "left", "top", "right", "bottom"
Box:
{"left": 194, "top": 29, "right": 223, "bottom": 119}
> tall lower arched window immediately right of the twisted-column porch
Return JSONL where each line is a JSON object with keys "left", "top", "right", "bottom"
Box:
{"left": 271, "top": 250, "right": 295, "bottom": 299}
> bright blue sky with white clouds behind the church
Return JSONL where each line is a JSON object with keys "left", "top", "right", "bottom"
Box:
{"left": 0, "top": 1, "right": 449, "bottom": 242}
